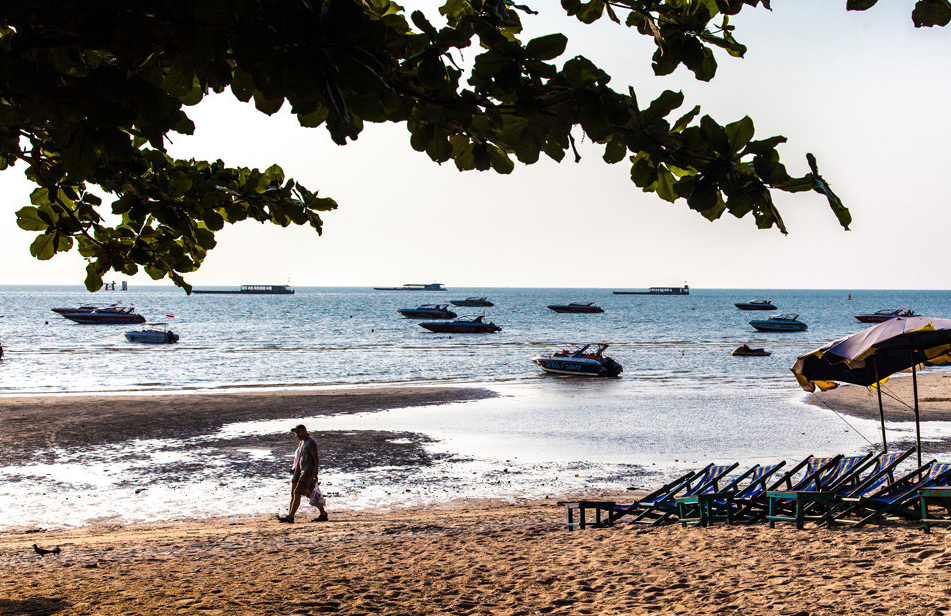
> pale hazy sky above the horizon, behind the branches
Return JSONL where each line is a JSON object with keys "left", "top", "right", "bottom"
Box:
{"left": 0, "top": 0, "right": 951, "bottom": 289}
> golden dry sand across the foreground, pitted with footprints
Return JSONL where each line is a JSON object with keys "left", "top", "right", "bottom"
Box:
{"left": 0, "top": 497, "right": 951, "bottom": 616}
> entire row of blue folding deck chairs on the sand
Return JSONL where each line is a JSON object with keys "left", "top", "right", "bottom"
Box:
{"left": 567, "top": 448, "right": 951, "bottom": 531}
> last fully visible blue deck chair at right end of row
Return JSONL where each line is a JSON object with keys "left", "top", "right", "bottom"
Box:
{"left": 834, "top": 460, "right": 951, "bottom": 528}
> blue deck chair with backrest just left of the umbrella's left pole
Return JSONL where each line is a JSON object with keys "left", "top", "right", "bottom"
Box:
{"left": 766, "top": 453, "right": 873, "bottom": 528}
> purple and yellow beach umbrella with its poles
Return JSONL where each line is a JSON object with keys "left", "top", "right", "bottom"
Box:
{"left": 792, "top": 316, "right": 951, "bottom": 466}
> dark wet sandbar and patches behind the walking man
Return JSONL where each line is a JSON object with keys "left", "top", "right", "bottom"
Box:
{"left": 0, "top": 387, "right": 497, "bottom": 468}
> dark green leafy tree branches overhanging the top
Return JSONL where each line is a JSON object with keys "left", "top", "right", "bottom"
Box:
{"left": 0, "top": 0, "right": 951, "bottom": 290}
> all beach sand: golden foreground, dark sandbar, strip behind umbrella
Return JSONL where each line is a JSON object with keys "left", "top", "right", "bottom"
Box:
{"left": 0, "top": 375, "right": 951, "bottom": 616}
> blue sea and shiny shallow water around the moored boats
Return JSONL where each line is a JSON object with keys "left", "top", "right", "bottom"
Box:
{"left": 0, "top": 287, "right": 951, "bottom": 526}
